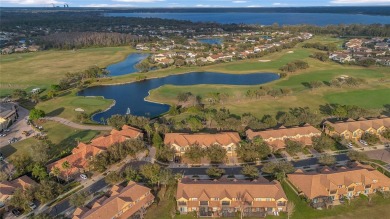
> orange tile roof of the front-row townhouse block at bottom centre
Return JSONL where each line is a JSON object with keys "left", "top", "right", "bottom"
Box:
{"left": 176, "top": 178, "right": 287, "bottom": 201}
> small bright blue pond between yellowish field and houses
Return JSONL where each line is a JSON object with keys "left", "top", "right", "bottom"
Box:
{"left": 107, "top": 53, "right": 149, "bottom": 76}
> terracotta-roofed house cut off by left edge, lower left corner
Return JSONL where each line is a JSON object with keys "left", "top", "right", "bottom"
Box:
{"left": 0, "top": 175, "right": 37, "bottom": 208}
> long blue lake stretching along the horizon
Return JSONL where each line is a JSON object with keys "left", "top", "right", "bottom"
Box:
{"left": 105, "top": 12, "right": 390, "bottom": 26}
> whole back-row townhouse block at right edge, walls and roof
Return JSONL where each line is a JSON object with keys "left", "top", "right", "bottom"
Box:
{"left": 324, "top": 117, "right": 390, "bottom": 140}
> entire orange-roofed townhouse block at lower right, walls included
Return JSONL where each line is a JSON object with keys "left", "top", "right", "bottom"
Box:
{"left": 287, "top": 164, "right": 390, "bottom": 208}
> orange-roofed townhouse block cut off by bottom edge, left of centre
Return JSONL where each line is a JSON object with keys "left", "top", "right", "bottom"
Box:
{"left": 72, "top": 181, "right": 154, "bottom": 219}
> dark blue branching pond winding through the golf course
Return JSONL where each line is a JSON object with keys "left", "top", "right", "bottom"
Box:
{"left": 78, "top": 72, "right": 279, "bottom": 122}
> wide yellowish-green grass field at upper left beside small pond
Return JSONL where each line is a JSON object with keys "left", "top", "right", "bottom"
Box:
{"left": 0, "top": 47, "right": 134, "bottom": 96}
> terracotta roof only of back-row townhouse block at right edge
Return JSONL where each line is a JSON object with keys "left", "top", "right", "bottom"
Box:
{"left": 325, "top": 117, "right": 390, "bottom": 133}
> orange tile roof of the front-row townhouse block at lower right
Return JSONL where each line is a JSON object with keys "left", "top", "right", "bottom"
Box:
{"left": 287, "top": 164, "right": 390, "bottom": 199}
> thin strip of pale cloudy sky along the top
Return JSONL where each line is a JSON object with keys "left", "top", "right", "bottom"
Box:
{"left": 0, "top": 0, "right": 390, "bottom": 8}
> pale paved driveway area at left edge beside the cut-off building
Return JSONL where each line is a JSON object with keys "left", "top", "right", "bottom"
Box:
{"left": 0, "top": 106, "right": 35, "bottom": 148}
